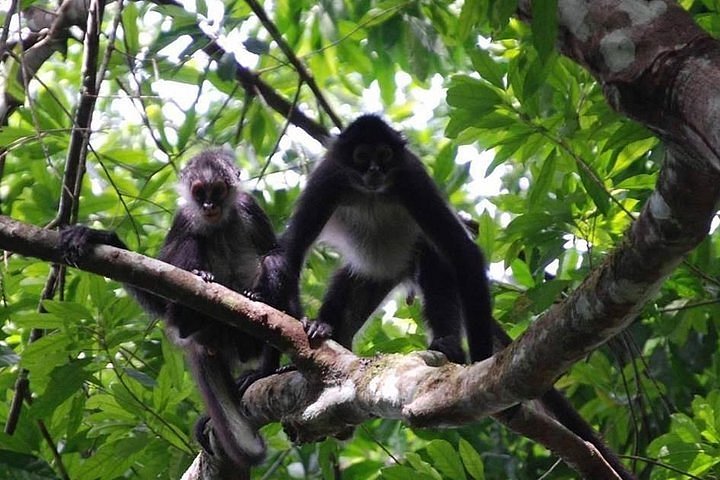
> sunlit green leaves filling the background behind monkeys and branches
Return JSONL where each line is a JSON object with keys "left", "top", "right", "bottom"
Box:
{"left": 0, "top": 0, "right": 720, "bottom": 480}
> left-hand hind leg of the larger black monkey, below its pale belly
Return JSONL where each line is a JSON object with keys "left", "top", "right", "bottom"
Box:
{"left": 308, "top": 266, "right": 398, "bottom": 348}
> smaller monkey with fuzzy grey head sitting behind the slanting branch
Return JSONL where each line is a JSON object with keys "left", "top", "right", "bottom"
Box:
{"left": 61, "top": 150, "right": 299, "bottom": 467}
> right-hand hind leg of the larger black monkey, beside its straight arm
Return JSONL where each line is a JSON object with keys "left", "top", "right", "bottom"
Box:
{"left": 417, "top": 242, "right": 467, "bottom": 363}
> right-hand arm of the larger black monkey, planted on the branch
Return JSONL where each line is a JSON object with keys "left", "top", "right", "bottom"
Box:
{"left": 394, "top": 159, "right": 492, "bottom": 362}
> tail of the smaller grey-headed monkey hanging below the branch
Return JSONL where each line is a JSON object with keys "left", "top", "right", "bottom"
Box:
{"left": 188, "top": 344, "right": 265, "bottom": 466}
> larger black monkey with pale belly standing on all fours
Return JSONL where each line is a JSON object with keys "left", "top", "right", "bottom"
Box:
{"left": 259, "top": 115, "right": 492, "bottom": 363}
